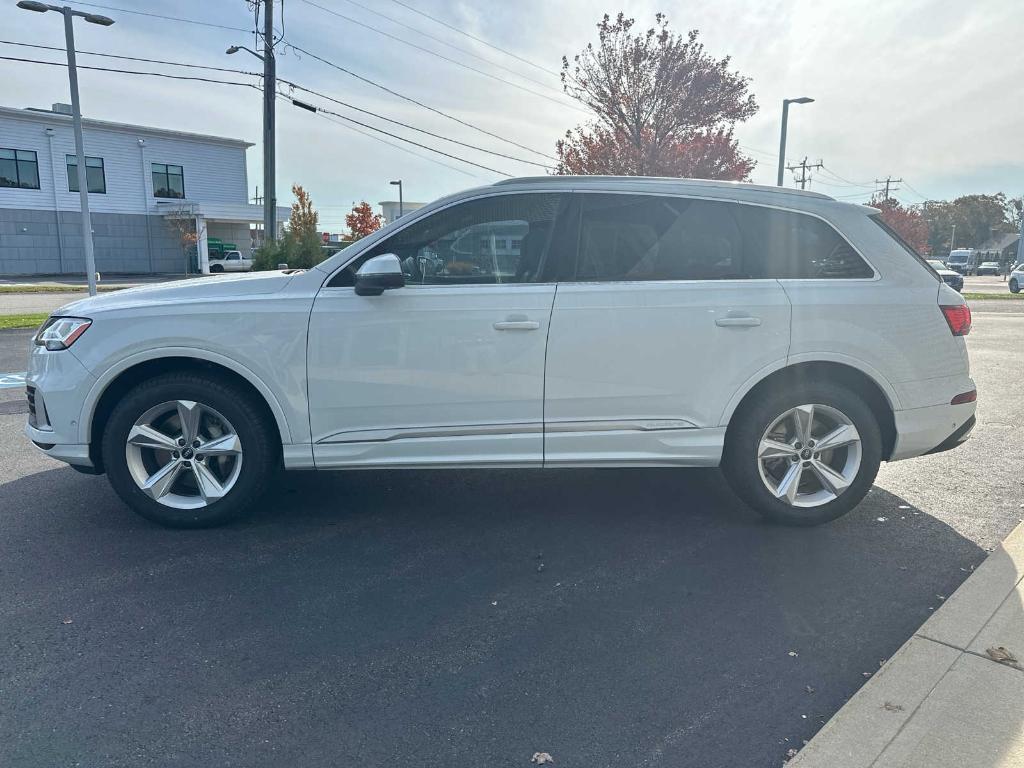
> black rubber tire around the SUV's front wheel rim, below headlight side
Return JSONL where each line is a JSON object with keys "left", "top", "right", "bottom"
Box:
{"left": 101, "top": 372, "right": 281, "bottom": 528}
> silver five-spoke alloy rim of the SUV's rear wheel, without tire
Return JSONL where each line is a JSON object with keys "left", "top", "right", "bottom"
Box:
{"left": 757, "top": 404, "right": 861, "bottom": 507}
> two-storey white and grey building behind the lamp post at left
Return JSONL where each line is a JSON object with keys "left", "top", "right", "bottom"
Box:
{"left": 0, "top": 104, "right": 290, "bottom": 275}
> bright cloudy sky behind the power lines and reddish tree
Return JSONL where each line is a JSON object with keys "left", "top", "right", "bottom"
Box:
{"left": 0, "top": 0, "right": 1024, "bottom": 231}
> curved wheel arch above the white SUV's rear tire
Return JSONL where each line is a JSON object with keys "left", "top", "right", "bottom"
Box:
{"left": 721, "top": 359, "right": 898, "bottom": 459}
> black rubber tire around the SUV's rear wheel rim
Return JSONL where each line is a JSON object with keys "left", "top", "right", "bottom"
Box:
{"left": 722, "top": 381, "right": 882, "bottom": 525}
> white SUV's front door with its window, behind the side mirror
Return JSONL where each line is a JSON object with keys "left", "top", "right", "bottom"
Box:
{"left": 308, "top": 194, "right": 564, "bottom": 468}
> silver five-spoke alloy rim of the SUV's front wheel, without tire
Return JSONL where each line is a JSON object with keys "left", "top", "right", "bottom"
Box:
{"left": 125, "top": 400, "right": 242, "bottom": 509}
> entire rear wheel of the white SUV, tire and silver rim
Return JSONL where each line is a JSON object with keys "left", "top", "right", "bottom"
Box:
{"left": 723, "top": 382, "right": 882, "bottom": 525}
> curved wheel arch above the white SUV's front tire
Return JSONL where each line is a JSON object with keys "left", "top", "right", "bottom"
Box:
{"left": 79, "top": 348, "right": 292, "bottom": 470}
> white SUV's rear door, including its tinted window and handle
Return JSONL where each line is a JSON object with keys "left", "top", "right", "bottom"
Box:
{"left": 545, "top": 194, "right": 791, "bottom": 466}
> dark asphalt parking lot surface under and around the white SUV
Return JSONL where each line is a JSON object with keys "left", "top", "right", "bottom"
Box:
{"left": 0, "top": 301, "right": 1024, "bottom": 768}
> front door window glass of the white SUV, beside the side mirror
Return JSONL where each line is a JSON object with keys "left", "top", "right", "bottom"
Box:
{"left": 332, "top": 194, "right": 564, "bottom": 286}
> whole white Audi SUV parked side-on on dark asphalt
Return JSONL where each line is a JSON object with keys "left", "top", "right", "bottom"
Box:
{"left": 26, "top": 176, "right": 977, "bottom": 527}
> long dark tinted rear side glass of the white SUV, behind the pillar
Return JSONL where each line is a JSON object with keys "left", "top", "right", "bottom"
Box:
{"left": 575, "top": 195, "right": 873, "bottom": 282}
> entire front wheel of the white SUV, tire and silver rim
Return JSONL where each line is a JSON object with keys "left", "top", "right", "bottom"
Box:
{"left": 102, "top": 373, "right": 276, "bottom": 528}
